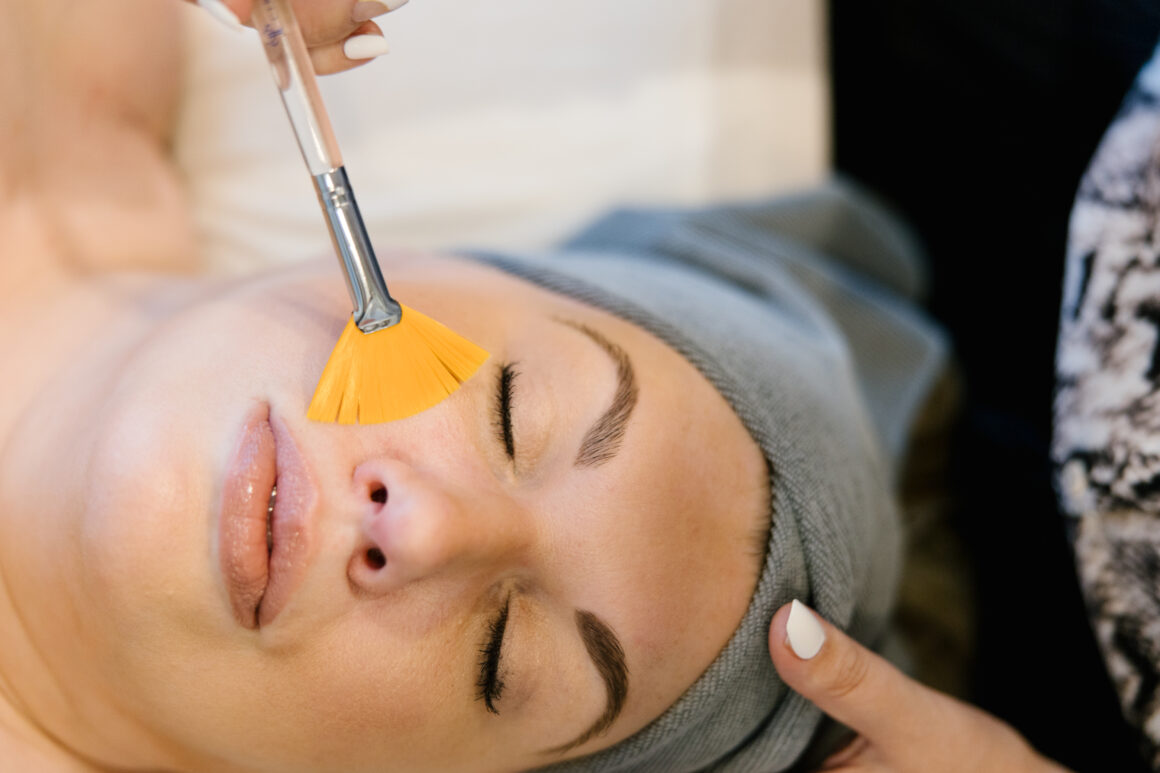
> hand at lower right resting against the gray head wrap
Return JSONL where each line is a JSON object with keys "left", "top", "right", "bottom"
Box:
{"left": 769, "top": 601, "right": 1065, "bottom": 773}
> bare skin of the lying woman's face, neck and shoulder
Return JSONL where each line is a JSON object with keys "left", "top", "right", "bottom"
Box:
{"left": 0, "top": 0, "right": 769, "bottom": 771}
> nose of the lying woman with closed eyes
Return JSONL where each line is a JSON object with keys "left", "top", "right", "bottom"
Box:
{"left": 347, "top": 458, "right": 532, "bottom": 595}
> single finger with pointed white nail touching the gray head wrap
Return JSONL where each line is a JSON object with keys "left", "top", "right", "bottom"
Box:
{"left": 769, "top": 601, "right": 933, "bottom": 749}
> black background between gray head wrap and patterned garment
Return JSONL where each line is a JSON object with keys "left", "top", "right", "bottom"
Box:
{"left": 829, "top": 0, "right": 1160, "bottom": 773}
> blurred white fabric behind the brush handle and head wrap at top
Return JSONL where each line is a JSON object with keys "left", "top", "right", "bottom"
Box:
{"left": 171, "top": 0, "right": 829, "bottom": 270}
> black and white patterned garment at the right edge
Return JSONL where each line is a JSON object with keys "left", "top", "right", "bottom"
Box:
{"left": 1052, "top": 39, "right": 1160, "bottom": 771}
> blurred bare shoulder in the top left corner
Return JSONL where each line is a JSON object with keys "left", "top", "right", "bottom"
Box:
{"left": 0, "top": 0, "right": 189, "bottom": 282}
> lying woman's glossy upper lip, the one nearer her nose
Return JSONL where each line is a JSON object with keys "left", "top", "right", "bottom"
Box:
{"left": 256, "top": 413, "right": 318, "bottom": 627}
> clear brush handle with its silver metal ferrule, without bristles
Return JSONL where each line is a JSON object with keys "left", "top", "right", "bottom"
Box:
{"left": 253, "top": 0, "right": 403, "bottom": 333}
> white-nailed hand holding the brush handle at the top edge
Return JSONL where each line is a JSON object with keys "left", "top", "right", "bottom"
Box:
{"left": 186, "top": 0, "right": 407, "bottom": 75}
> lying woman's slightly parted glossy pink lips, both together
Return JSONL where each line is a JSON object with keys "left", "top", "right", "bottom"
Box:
{"left": 218, "top": 405, "right": 317, "bottom": 629}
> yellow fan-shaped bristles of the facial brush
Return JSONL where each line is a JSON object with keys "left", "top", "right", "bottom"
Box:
{"left": 306, "top": 306, "right": 491, "bottom": 424}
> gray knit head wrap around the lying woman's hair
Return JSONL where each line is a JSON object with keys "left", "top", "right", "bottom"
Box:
{"left": 466, "top": 186, "right": 943, "bottom": 773}
